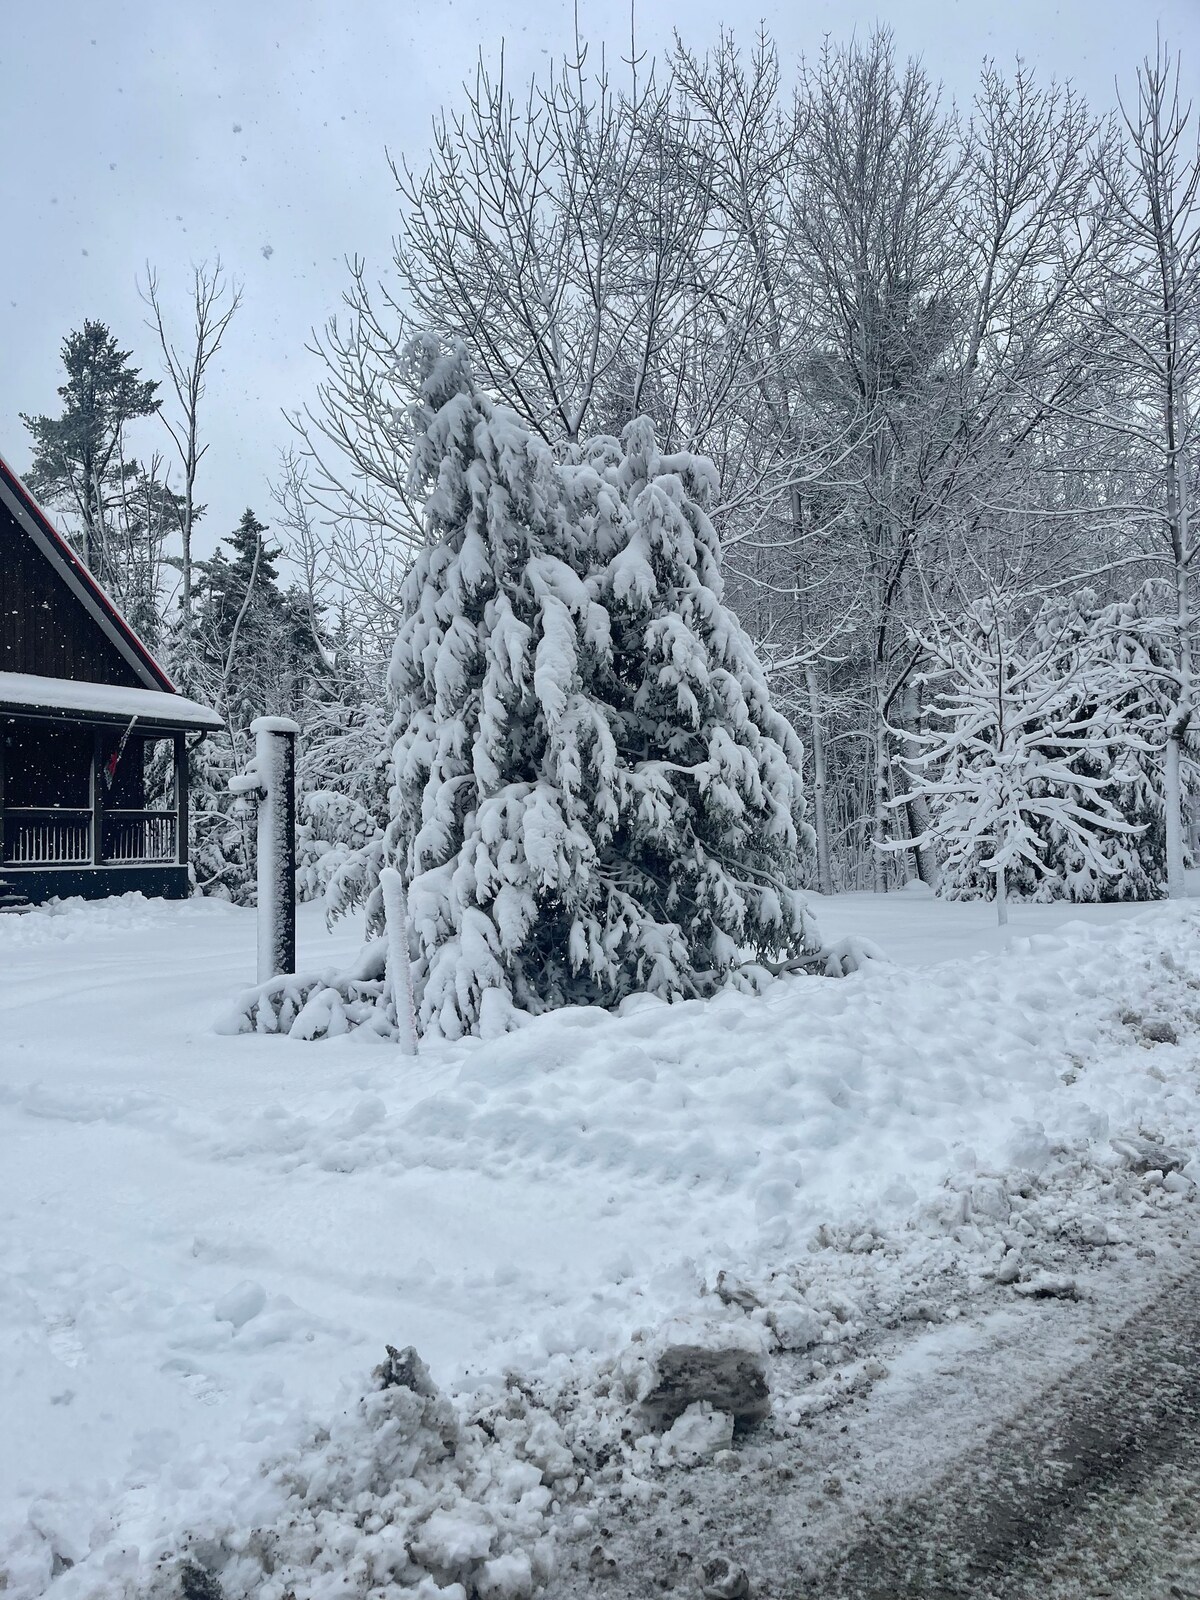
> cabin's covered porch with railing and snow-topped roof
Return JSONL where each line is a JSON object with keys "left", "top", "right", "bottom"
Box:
{"left": 0, "top": 672, "right": 221, "bottom": 902}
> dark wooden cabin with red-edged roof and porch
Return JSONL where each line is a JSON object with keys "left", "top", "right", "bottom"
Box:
{"left": 0, "top": 458, "right": 221, "bottom": 907}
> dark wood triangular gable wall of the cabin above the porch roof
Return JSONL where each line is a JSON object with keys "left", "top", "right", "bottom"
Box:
{"left": 0, "top": 504, "right": 141, "bottom": 686}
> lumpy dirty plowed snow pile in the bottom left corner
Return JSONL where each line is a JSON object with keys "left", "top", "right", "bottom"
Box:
{"left": 0, "top": 1347, "right": 576, "bottom": 1600}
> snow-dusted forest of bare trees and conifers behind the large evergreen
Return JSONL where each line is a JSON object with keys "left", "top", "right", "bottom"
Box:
{"left": 16, "top": 32, "right": 1200, "bottom": 902}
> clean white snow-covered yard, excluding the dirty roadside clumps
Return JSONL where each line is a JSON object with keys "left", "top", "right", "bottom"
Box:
{"left": 0, "top": 893, "right": 1200, "bottom": 1597}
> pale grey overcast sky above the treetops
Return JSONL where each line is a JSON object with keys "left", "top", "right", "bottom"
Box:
{"left": 0, "top": 0, "right": 1200, "bottom": 556}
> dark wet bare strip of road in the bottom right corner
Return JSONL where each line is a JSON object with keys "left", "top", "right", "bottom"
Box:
{"left": 809, "top": 1266, "right": 1200, "bottom": 1600}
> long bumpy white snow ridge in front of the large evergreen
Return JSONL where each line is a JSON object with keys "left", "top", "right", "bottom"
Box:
{"left": 209, "top": 912, "right": 1194, "bottom": 1245}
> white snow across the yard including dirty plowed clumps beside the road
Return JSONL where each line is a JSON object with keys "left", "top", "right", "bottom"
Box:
{"left": 0, "top": 896, "right": 1200, "bottom": 1600}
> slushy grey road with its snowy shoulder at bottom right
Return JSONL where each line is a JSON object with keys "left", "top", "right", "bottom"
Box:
{"left": 550, "top": 1237, "right": 1200, "bottom": 1600}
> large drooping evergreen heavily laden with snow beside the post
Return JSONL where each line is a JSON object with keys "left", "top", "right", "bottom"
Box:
{"left": 320, "top": 338, "right": 818, "bottom": 1037}
